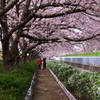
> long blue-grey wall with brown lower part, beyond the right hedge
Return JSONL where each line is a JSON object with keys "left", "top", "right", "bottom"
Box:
{"left": 53, "top": 57, "right": 100, "bottom": 72}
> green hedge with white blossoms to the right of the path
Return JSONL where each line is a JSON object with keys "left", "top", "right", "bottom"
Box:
{"left": 47, "top": 60, "right": 100, "bottom": 100}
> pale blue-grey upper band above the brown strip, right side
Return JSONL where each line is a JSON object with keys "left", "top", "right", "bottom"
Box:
{"left": 53, "top": 57, "right": 100, "bottom": 65}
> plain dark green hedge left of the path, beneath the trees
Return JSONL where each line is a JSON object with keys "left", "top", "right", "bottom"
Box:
{"left": 0, "top": 60, "right": 38, "bottom": 100}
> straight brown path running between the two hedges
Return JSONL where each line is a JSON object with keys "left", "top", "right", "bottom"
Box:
{"left": 33, "top": 69, "right": 69, "bottom": 100}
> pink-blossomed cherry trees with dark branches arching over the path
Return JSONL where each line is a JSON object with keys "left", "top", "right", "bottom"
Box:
{"left": 0, "top": 0, "right": 100, "bottom": 70}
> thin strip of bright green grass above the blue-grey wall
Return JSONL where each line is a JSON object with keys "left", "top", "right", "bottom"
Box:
{"left": 63, "top": 52, "right": 100, "bottom": 57}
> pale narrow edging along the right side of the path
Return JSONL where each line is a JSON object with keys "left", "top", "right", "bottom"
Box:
{"left": 49, "top": 69, "right": 77, "bottom": 100}
